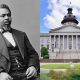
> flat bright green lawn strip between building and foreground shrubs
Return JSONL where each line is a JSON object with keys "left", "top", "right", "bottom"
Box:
{"left": 40, "top": 64, "right": 80, "bottom": 69}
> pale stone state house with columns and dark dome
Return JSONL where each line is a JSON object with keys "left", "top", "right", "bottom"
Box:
{"left": 40, "top": 8, "right": 80, "bottom": 60}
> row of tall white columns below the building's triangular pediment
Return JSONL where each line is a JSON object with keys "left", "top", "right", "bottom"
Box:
{"left": 50, "top": 34, "right": 80, "bottom": 51}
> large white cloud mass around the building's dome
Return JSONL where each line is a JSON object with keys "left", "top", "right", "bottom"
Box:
{"left": 44, "top": 0, "right": 80, "bottom": 29}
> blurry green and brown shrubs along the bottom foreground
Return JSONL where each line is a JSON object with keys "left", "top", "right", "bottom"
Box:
{"left": 40, "top": 69, "right": 80, "bottom": 80}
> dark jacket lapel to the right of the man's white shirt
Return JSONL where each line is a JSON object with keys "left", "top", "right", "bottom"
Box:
{"left": 12, "top": 29, "right": 24, "bottom": 59}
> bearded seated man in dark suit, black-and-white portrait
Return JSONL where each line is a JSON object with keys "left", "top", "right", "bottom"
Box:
{"left": 0, "top": 4, "right": 40, "bottom": 80}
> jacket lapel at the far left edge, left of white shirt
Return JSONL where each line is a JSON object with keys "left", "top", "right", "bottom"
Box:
{"left": 0, "top": 33, "right": 10, "bottom": 60}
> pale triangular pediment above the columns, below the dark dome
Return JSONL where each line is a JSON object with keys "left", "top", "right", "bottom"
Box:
{"left": 50, "top": 26, "right": 80, "bottom": 32}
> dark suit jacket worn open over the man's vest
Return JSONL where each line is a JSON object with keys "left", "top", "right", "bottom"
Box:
{"left": 0, "top": 29, "right": 39, "bottom": 72}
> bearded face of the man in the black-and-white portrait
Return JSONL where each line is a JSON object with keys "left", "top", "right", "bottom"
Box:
{"left": 0, "top": 8, "right": 12, "bottom": 28}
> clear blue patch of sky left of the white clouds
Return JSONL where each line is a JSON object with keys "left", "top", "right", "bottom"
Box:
{"left": 40, "top": 0, "right": 49, "bottom": 32}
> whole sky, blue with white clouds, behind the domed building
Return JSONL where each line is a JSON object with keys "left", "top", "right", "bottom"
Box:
{"left": 40, "top": 0, "right": 80, "bottom": 33}
